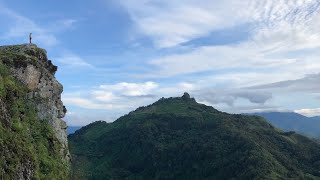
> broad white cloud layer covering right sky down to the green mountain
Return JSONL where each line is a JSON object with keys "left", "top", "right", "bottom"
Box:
{"left": 63, "top": 0, "right": 320, "bottom": 124}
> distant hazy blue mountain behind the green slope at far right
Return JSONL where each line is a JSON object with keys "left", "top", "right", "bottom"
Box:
{"left": 254, "top": 112, "right": 320, "bottom": 138}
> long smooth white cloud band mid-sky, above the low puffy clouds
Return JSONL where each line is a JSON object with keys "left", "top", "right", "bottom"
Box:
{"left": 150, "top": 43, "right": 302, "bottom": 77}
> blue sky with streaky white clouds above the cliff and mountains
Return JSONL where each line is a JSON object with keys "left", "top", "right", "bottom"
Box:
{"left": 0, "top": 0, "right": 320, "bottom": 126}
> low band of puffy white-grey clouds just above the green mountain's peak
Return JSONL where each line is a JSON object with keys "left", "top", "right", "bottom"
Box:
{"left": 62, "top": 80, "right": 318, "bottom": 125}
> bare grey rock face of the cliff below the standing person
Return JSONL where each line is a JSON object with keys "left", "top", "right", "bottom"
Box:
{"left": 0, "top": 44, "right": 70, "bottom": 161}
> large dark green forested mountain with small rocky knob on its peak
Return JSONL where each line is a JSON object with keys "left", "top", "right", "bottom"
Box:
{"left": 68, "top": 93, "right": 320, "bottom": 179}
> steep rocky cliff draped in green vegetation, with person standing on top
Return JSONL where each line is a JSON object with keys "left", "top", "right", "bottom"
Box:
{"left": 0, "top": 44, "right": 70, "bottom": 179}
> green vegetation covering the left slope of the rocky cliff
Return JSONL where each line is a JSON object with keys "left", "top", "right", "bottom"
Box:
{"left": 0, "top": 51, "right": 69, "bottom": 180}
